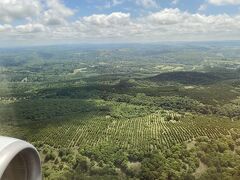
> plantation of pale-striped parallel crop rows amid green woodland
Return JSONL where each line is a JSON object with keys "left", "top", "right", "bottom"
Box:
{"left": 21, "top": 112, "right": 232, "bottom": 151}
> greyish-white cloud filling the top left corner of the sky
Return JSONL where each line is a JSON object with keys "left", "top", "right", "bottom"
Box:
{"left": 0, "top": 0, "right": 41, "bottom": 23}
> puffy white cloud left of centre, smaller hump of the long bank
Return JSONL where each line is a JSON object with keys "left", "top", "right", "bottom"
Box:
{"left": 71, "top": 12, "right": 140, "bottom": 41}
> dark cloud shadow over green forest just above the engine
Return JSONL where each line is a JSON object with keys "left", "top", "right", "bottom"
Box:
{"left": 1, "top": 90, "right": 108, "bottom": 141}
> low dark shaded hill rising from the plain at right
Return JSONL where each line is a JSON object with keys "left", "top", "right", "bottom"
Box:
{"left": 148, "top": 71, "right": 221, "bottom": 84}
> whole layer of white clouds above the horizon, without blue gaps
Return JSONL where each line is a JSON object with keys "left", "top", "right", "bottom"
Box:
{"left": 0, "top": 0, "right": 240, "bottom": 44}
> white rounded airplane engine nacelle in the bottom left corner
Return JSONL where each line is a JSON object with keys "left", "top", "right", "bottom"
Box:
{"left": 0, "top": 136, "right": 42, "bottom": 180}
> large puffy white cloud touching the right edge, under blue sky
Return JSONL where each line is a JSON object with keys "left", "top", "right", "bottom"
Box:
{"left": 147, "top": 9, "right": 240, "bottom": 39}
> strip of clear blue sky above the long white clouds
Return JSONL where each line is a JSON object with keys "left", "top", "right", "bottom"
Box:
{"left": 64, "top": 0, "right": 240, "bottom": 16}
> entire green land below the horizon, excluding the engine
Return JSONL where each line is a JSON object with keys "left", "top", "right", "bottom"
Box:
{"left": 0, "top": 43, "right": 240, "bottom": 180}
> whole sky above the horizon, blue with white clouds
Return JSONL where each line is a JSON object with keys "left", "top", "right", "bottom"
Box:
{"left": 0, "top": 0, "right": 240, "bottom": 46}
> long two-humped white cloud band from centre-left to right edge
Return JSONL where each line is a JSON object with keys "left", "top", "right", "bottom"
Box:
{"left": 65, "top": 9, "right": 240, "bottom": 41}
